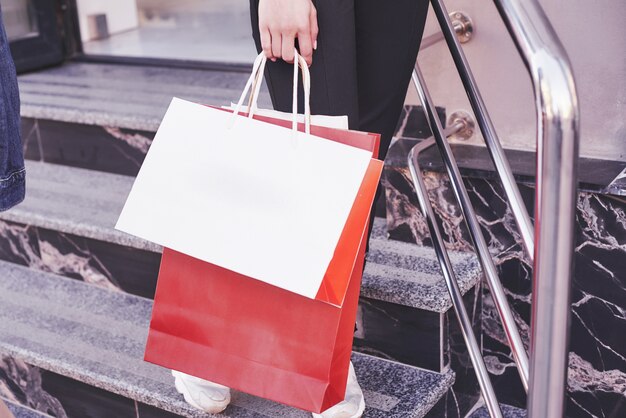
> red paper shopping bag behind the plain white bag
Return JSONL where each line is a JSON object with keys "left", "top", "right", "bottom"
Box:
{"left": 145, "top": 114, "right": 382, "bottom": 412}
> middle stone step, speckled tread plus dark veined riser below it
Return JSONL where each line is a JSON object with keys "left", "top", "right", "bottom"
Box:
{"left": 0, "top": 161, "right": 480, "bottom": 372}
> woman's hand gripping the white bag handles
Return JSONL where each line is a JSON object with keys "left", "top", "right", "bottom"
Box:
{"left": 259, "top": 0, "right": 318, "bottom": 65}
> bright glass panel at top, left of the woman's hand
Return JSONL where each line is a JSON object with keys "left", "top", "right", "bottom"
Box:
{"left": 77, "top": 0, "right": 257, "bottom": 65}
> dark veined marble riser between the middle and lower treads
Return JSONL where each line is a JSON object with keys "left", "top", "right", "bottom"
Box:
{"left": 0, "top": 221, "right": 444, "bottom": 372}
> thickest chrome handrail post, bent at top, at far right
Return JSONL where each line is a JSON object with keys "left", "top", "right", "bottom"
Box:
{"left": 494, "top": 0, "right": 580, "bottom": 418}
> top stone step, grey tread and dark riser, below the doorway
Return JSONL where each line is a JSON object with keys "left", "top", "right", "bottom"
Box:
{"left": 18, "top": 62, "right": 271, "bottom": 175}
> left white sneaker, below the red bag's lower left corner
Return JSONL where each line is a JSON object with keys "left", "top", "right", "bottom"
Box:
{"left": 172, "top": 370, "right": 230, "bottom": 414}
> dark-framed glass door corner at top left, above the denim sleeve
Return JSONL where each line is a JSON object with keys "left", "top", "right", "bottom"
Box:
{"left": 0, "top": 0, "right": 64, "bottom": 72}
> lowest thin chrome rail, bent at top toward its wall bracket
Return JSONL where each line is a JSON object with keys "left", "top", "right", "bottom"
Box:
{"left": 407, "top": 137, "right": 502, "bottom": 418}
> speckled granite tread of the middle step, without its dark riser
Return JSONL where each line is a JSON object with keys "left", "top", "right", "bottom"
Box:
{"left": 0, "top": 161, "right": 480, "bottom": 312}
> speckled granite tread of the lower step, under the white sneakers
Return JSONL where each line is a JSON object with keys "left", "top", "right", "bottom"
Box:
{"left": 0, "top": 262, "right": 454, "bottom": 417}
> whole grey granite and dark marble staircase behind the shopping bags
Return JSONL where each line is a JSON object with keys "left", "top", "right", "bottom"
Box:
{"left": 0, "top": 63, "right": 488, "bottom": 418}
